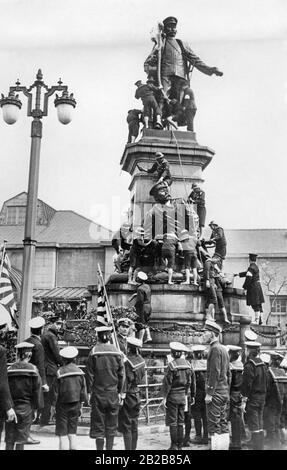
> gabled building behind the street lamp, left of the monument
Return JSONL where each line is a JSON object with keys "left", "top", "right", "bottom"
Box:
{"left": 0, "top": 192, "right": 113, "bottom": 315}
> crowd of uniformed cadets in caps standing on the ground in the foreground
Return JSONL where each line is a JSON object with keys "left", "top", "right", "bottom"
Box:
{"left": 0, "top": 308, "right": 287, "bottom": 450}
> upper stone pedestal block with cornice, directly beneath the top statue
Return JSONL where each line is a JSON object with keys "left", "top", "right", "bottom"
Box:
{"left": 121, "top": 129, "right": 214, "bottom": 226}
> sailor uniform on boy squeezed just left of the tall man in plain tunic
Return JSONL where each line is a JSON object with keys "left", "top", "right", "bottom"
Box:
{"left": 191, "top": 359, "right": 208, "bottom": 444}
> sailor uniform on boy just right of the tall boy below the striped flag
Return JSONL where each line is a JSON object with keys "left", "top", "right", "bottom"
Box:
{"left": 118, "top": 355, "right": 145, "bottom": 450}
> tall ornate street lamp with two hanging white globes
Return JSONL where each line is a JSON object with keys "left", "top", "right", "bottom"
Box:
{"left": 0, "top": 69, "right": 76, "bottom": 341}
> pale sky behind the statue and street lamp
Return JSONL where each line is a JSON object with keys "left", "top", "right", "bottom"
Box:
{"left": 0, "top": 0, "right": 287, "bottom": 230}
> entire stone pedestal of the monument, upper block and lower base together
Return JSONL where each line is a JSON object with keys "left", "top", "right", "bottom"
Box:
{"left": 110, "top": 129, "right": 280, "bottom": 352}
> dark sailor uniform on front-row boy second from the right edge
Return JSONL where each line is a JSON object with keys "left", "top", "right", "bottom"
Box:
{"left": 241, "top": 357, "right": 267, "bottom": 450}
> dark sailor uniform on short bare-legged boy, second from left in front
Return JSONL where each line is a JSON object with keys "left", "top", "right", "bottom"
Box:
{"left": 52, "top": 363, "right": 87, "bottom": 436}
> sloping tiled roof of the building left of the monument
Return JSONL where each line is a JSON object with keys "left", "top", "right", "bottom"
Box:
{"left": 0, "top": 211, "right": 112, "bottom": 245}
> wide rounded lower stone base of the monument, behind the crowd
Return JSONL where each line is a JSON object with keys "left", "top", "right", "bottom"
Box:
{"left": 107, "top": 283, "right": 258, "bottom": 349}
